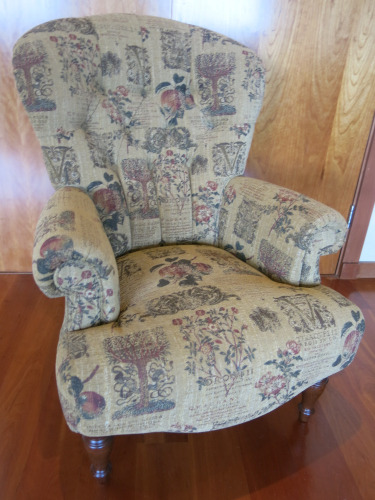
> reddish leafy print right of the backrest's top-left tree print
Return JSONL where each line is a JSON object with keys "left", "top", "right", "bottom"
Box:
{"left": 50, "top": 33, "right": 100, "bottom": 96}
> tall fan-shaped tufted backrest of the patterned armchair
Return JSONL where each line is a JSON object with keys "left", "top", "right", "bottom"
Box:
{"left": 13, "top": 14, "right": 264, "bottom": 255}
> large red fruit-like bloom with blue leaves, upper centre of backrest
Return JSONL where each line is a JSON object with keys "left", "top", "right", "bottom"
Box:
{"left": 155, "top": 73, "right": 195, "bottom": 126}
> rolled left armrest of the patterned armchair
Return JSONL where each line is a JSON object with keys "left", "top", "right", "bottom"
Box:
{"left": 33, "top": 187, "right": 120, "bottom": 330}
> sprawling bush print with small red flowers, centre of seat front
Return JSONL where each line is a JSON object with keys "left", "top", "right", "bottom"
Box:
{"left": 173, "top": 307, "right": 255, "bottom": 396}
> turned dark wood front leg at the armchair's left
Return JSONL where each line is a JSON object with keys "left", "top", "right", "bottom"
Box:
{"left": 82, "top": 436, "right": 113, "bottom": 483}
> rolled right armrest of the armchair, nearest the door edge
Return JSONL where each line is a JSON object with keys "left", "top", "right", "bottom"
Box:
{"left": 218, "top": 177, "right": 347, "bottom": 285}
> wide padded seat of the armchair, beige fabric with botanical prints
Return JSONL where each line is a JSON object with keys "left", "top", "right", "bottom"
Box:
{"left": 57, "top": 245, "right": 364, "bottom": 436}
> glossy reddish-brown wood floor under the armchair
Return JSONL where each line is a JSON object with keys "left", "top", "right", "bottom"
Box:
{"left": 0, "top": 275, "right": 375, "bottom": 500}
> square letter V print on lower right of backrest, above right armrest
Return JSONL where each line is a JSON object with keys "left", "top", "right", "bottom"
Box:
{"left": 212, "top": 141, "right": 246, "bottom": 177}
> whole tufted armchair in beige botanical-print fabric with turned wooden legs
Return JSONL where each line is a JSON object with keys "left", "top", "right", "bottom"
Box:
{"left": 13, "top": 14, "right": 364, "bottom": 478}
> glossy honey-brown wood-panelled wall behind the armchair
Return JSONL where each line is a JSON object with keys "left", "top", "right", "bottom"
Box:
{"left": 0, "top": 0, "right": 375, "bottom": 273}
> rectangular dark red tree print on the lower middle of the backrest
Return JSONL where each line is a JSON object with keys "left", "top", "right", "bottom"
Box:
{"left": 121, "top": 158, "right": 159, "bottom": 219}
